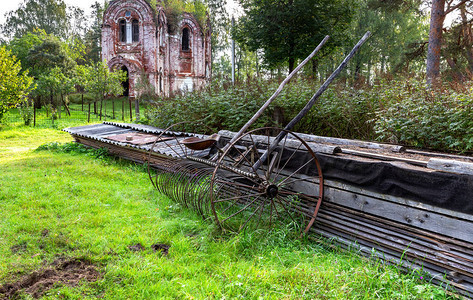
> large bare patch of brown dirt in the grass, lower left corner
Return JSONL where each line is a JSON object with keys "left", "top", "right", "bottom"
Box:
{"left": 0, "top": 259, "right": 100, "bottom": 299}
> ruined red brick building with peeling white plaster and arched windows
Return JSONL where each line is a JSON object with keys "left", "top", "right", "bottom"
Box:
{"left": 102, "top": 0, "right": 211, "bottom": 97}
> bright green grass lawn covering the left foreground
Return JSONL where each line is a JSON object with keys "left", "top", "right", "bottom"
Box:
{"left": 0, "top": 121, "right": 453, "bottom": 299}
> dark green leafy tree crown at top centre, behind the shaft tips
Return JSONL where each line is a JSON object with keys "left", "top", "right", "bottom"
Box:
{"left": 234, "top": 0, "right": 355, "bottom": 72}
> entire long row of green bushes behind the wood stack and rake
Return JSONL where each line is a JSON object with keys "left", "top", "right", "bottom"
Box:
{"left": 146, "top": 78, "right": 473, "bottom": 151}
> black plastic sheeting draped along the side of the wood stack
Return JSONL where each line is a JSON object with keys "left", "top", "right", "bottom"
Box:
{"left": 317, "top": 154, "right": 473, "bottom": 214}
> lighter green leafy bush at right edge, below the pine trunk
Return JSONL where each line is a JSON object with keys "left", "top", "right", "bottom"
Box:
{"left": 374, "top": 79, "right": 473, "bottom": 152}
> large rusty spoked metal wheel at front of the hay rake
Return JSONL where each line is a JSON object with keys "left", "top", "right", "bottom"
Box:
{"left": 210, "top": 128, "right": 323, "bottom": 233}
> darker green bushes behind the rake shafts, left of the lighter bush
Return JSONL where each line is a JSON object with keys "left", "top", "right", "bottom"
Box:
{"left": 145, "top": 80, "right": 377, "bottom": 139}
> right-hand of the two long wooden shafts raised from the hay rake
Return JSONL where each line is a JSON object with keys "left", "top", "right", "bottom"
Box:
{"left": 253, "top": 31, "right": 371, "bottom": 170}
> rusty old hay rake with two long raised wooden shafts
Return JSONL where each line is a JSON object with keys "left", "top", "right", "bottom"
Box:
{"left": 149, "top": 32, "right": 370, "bottom": 233}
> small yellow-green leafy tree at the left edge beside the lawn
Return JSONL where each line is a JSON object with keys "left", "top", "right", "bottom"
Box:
{"left": 0, "top": 47, "right": 34, "bottom": 121}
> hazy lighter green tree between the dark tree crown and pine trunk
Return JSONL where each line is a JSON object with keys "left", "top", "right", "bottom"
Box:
{"left": 345, "top": 0, "right": 428, "bottom": 81}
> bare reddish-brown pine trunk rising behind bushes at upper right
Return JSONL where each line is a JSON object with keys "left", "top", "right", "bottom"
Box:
{"left": 426, "top": 0, "right": 445, "bottom": 88}
